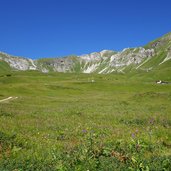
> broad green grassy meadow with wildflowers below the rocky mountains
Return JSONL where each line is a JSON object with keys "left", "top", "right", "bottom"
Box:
{"left": 0, "top": 67, "right": 171, "bottom": 171}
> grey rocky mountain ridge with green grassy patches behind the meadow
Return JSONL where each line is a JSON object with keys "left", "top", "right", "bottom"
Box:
{"left": 0, "top": 33, "right": 171, "bottom": 74}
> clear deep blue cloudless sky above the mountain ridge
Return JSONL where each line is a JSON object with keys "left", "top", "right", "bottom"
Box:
{"left": 0, "top": 0, "right": 171, "bottom": 58}
